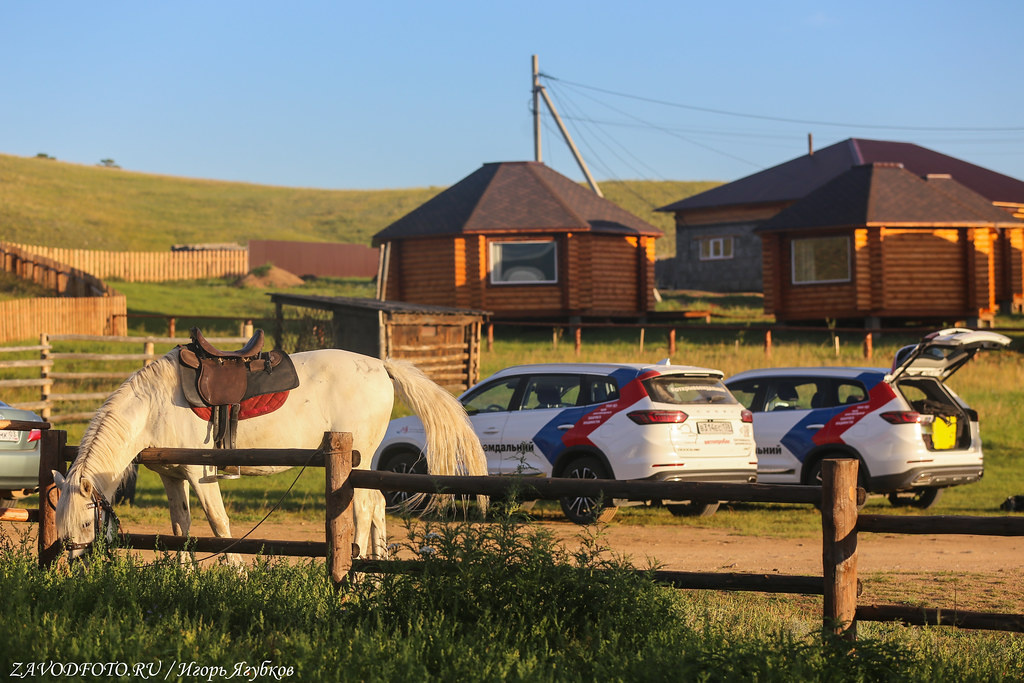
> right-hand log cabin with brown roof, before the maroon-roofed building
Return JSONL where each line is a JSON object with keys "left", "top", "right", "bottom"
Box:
{"left": 757, "top": 164, "right": 1024, "bottom": 328}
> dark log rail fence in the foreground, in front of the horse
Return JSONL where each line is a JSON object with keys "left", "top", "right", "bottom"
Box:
{"left": 6, "top": 432, "right": 1024, "bottom": 640}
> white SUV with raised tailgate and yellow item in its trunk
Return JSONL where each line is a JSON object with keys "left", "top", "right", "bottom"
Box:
{"left": 726, "top": 328, "right": 1010, "bottom": 508}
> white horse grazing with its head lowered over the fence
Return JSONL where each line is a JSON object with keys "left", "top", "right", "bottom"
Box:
{"left": 54, "top": 349, "right": 486, "bottom": 563}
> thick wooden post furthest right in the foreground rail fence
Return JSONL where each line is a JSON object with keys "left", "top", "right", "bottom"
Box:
{"left": 821, "top": 458, "right": 858, "bottom": 640}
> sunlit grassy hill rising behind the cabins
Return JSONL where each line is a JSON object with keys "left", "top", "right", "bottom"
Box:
{"left": 0, "top": 155, "right": 719, "bottom": 257}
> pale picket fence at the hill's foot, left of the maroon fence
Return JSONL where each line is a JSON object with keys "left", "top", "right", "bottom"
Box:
{"left": 10, "top": 245, "right": 249, "bottom": 283}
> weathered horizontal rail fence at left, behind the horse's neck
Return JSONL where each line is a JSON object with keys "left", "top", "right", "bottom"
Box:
{"left": 0, "top": 331, "right": 253, "bottom": 424}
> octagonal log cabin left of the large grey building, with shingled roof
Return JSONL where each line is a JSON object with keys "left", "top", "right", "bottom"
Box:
{"left": 374, "top": 162, "right": 662, "bottom": 319}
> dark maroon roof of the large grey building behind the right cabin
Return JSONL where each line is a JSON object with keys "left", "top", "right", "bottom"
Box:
{"left": 657, "top": 137, "right": 1024, "bottom": 211}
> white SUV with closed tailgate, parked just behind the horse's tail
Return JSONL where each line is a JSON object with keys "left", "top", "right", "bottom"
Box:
{"left": 371, "top": 360, "right": 757, "bottom": 523}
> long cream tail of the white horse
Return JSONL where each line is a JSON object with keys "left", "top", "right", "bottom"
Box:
{"left": 384, "top": 358, "right": 487, "bottom": 509}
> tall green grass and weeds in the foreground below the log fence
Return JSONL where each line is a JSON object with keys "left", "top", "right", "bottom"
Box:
{"left": 0, "top": 516, "right": 1024, "bottom": 682}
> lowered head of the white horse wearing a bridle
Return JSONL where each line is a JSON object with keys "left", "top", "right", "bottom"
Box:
{"left": 53, "top": 471, "right": 120, "bottom": 560}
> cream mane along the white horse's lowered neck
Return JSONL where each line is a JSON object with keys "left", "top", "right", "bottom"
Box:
{"left": 56, "top": 349, "right": 177, "bottom": 537}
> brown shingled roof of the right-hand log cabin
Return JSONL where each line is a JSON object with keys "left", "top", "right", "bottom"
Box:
{"left": 758, "top": 164, "right": 1024, "bottom": 231}
